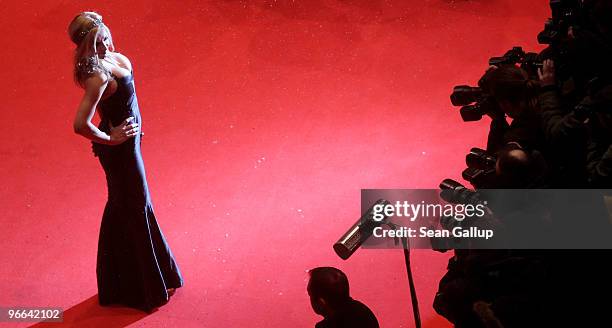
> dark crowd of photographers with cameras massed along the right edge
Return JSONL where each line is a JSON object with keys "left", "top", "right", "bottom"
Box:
{"left": 434, "top": 0, "right": 612, "bottom": 328}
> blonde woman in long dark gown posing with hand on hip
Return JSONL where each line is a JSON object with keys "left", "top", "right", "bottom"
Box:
{"left": 68, "top": 12, "right": 183, "bottom": 312}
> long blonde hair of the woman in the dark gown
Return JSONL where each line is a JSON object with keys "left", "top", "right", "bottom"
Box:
{"left": 68, "top": 11, "right": 115, "bottom": 88}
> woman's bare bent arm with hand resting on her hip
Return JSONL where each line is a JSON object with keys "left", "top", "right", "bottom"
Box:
{"left": 73, "top": 74, "right": 139, "bottom": 145}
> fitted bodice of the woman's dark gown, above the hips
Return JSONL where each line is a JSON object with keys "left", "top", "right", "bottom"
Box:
{"left": 92, "top": 74, "right": 142, "bottom": 156}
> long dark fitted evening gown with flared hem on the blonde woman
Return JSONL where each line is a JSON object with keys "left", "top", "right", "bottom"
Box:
{"left": 93, "top": 74, "right": 183, "bottom": 312}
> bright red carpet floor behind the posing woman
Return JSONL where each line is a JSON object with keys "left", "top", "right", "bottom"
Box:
{"left": 0, "top": 0, "right": 549, "bottom": 327}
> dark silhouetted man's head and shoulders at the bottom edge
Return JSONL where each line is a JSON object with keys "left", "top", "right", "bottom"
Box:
{"left": 307, "top": 267, "right": 379, "bottom": 328}
